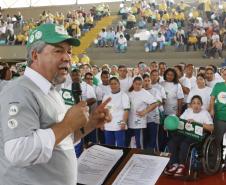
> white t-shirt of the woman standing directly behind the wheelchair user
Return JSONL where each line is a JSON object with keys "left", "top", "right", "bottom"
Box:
{"left": 187, "top": 86, "right": 212, "bottom": 110}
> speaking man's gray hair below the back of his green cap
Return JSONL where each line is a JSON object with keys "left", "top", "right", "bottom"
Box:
{"left": 27, "top": 41, "right": 47, "bottom": 67}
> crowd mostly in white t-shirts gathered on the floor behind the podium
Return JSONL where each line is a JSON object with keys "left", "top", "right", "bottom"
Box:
{"left": 0, "top": 58, "right": 226, "bottom": 176}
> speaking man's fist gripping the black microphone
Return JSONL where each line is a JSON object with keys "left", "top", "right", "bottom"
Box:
{"left": 62, "top": 101, "right": 89, "bottom": 132}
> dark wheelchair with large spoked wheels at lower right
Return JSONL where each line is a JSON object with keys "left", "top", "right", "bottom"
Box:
{"left": 185, "top": 134, "right": 223, "bottom": 180}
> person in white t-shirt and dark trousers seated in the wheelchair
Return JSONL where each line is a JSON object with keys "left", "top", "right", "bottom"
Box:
{"left": 164, "top": 95, "right": 214, "bottom": 177}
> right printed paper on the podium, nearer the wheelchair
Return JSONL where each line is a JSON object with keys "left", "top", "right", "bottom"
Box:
{"left": 113, "top": 154, "right": 169, "bottom": 185}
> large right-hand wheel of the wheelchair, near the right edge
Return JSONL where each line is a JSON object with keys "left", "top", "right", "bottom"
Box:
{"left": 201, "top": 135, "right": 222, "bottom": 175}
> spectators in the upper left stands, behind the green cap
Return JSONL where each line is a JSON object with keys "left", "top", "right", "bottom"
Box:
{"left": 0, "top": 3, "right": 110, "bottom": 45}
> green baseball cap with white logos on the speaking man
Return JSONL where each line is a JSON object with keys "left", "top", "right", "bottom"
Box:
{"left": 26, "top": 24, "right": 80, "bottom": 48}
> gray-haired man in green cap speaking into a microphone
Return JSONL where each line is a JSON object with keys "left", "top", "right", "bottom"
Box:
{"left": 0, "top": 24, "right": 111, "bottom": 185}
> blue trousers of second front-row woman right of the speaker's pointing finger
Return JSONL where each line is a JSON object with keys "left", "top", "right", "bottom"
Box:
{"left": 126, "top": 128, "right": 142, "bottom": 148}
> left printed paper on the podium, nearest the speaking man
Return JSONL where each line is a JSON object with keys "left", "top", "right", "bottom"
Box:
{"left": 78, "top": 145, "right": 123, "bottom": 185}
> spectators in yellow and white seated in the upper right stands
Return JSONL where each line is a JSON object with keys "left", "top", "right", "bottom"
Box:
{"left": 116, "top": 0, "right": 226, "bottom": 58}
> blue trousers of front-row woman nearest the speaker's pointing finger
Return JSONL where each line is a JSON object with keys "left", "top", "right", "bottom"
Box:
{"left": 104, "top": 130, "right": 126, "bottom": 147}
